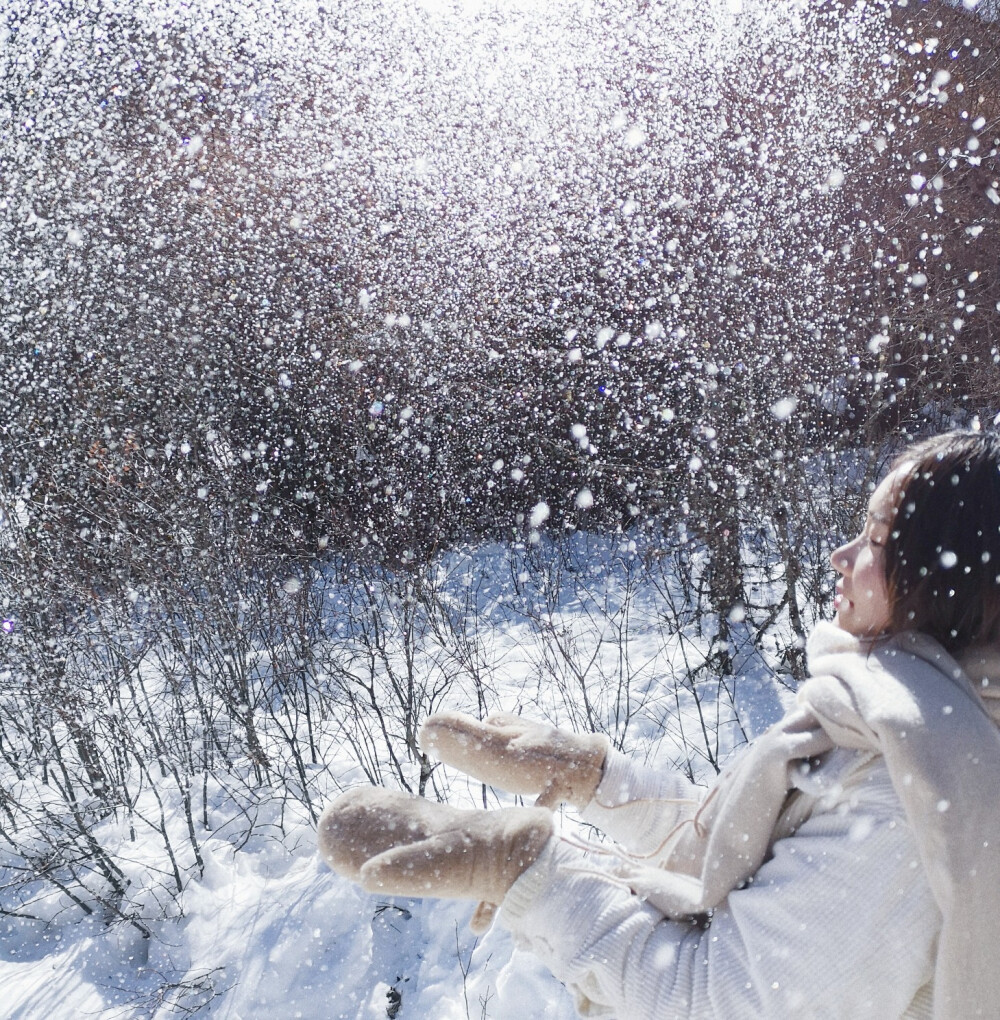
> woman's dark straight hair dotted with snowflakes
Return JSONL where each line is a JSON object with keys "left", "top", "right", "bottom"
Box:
{"left": 886, "top": 431, "right": 1000, "bottom": 651}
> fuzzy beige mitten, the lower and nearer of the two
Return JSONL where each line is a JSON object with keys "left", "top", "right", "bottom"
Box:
{"left": 317, "top": 786, "right": 552, "bottom": 930}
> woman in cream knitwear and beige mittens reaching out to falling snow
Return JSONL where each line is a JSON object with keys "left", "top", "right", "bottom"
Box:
{"left": 319, "top": 432, "right": 1000, "bottom": 1020}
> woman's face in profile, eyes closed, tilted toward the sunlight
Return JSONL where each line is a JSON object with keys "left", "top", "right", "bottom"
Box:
{"left": 831, "top": 471, "right": 898, "bottom": 638}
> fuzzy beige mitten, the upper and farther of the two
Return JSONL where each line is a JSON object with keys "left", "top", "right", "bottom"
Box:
{"left": 419, "top": 712, "right": 610, "bottom": 810}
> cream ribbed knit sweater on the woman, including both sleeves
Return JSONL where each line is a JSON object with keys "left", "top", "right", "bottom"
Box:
{"left": 501, "top": 628, "right": 1000, "bottom": 1020}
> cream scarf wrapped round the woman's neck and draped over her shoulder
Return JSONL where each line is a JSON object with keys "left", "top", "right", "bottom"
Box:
{"left": 627, "top": 623, "right": 1000, "bottom": 1020}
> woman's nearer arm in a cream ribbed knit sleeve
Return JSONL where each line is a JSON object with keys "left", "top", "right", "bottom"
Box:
{"left": 501, "top": 762, "right": 940, "bottom": 1020}
